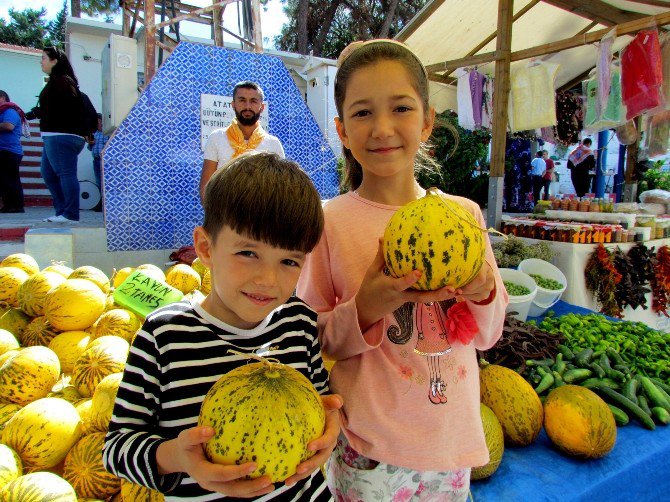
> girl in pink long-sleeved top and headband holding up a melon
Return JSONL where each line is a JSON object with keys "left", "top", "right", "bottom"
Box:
{"left": 298, "top": 40, "right": 508, "bottom": 501}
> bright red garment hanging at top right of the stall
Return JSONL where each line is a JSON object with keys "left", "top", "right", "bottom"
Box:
{"left": 621, "top": 30, "right": 663, "bottom": 120}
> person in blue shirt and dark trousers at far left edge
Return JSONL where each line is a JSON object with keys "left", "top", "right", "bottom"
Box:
{"left": 0, "top": 91, "right": 27, "bottom": 213}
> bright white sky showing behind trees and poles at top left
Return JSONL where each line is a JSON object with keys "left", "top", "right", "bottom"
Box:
{"left": 0, "top": 0, "right": 287, "bottom": 48}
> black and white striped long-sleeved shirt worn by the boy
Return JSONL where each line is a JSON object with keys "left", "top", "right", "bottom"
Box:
{"left": 103, "top": 297, "right": 332, "bottom": 501}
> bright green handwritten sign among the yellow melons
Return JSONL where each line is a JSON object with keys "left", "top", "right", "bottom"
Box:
{"left": 114, "top": 270, "right": 184, "bottom": 317}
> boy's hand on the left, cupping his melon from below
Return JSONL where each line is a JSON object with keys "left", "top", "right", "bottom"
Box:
{"left": 156, "top": 427, "right": 274, "bottom": 498}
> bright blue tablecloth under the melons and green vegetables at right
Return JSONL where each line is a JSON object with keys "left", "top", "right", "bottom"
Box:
{"left": 472, "top": 301, "right": 670, "bottom": 502}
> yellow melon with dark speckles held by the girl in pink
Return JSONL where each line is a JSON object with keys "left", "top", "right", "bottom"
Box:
{"left": 383, "top": 192, "right": 486, "bottom": 290}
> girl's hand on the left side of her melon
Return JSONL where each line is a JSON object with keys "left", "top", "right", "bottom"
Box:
{"left": 356, "top": 239, "right": 456, "bottom": 331}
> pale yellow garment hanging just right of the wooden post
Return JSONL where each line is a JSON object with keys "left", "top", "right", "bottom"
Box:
{"left": 509, "top": 62, "right": 559, "bottom": 131}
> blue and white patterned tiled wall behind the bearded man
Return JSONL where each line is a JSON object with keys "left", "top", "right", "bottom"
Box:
{"left": 103, "top": 43, "right": 338, "bottom": 251}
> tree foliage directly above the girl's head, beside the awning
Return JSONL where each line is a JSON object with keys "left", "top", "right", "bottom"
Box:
{"left": 262, "top": 0, "right": 427, "bottom": 58}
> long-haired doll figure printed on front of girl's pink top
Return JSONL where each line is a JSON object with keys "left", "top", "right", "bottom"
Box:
{"left": 386, "top": 300, "right": 455, "bottom": 404}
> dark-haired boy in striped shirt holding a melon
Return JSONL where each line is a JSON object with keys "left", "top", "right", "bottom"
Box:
{"left": 103, "top": 153, "right": 342, "bottom": 501}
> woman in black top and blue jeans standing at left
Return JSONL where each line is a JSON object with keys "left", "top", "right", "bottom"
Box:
{"left": 26, "top": 47, "right": 86, "bottom": 224}
